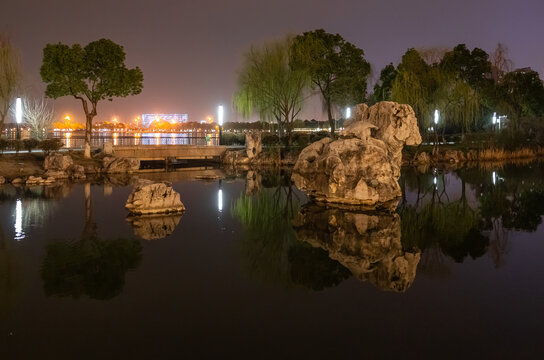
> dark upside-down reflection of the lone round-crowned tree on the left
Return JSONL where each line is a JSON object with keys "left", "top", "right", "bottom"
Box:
{"left": 41, "top": 183, "right": 142, "bottom": 300}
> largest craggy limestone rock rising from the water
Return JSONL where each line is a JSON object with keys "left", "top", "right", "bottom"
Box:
{"left": 292, "top": 101, "right": 421, "bottom": 209}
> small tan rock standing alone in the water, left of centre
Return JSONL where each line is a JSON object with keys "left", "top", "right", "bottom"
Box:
{"left": 125, "top": 181, "right": 185, "bottom": 215}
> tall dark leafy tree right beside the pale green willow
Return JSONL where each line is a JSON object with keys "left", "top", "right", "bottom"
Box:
{"left": 291, "top": 29, "right": 370, "bottom": 137}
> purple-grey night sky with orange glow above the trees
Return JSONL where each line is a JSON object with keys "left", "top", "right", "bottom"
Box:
{"left": 0, "top": 0, "right": 544, "bottom": 122}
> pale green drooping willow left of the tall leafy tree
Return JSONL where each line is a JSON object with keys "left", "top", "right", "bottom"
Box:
{"left": 233, "top": 37, "right": 308, "bottom": 144}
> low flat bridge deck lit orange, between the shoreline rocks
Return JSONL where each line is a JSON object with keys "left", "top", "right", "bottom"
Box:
{"left": 112, "top": 145, "right": 226, "bottom": 162}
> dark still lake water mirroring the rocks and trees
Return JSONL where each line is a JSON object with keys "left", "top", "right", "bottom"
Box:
{"left": 0, "top": 163, "right": 544, "bottom": 359}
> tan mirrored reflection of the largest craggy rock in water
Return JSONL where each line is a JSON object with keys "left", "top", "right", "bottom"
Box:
{"left": 293, "top": 204, "right": 420, "bottom": 292}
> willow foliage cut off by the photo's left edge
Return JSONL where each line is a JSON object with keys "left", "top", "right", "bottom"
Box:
{"left": 0, "top": 36, "right": 22, "bottom": 129}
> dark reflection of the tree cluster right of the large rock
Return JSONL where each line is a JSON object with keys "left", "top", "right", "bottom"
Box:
{"left": 398, "top": 163, "right": 544, "bottom": 276}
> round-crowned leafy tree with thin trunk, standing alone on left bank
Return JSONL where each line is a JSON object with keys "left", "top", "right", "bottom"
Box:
{"left": 40, "top": 39, "right": 143, "bottom": 158}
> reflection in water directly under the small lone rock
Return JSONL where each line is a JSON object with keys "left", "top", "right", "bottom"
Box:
{"left": 127, "top": 214, "right": 182, "bottom": 240}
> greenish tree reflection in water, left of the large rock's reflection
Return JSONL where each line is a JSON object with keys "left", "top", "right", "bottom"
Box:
{"left": 232, "top": 172, "right": 350, "bottom": 290}
